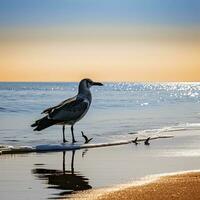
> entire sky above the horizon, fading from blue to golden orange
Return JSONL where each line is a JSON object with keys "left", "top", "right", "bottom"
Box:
{"left": 0, "top": 0, "right": 200, "bottom": 82}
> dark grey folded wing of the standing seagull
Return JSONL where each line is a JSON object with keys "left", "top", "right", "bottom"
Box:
{"left": 48, "top": 98, "right": 90, "bottom": 122}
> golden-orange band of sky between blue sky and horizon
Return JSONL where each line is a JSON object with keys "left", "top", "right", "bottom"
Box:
{"left": 0, "top": 27, "right": 200, "bottom": 81}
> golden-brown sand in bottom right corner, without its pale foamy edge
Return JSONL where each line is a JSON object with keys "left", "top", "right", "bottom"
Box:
{"left": 96, "top": 172, "right": 200, "bottom": 200}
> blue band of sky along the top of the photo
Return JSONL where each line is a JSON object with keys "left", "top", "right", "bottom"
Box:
{"left": 0, "top": 0, "right": 200, "bottom": 27}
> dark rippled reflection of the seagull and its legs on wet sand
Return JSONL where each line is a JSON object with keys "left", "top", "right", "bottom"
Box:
{"left": 32, "top": 151, "right": 92, "bottom": 199}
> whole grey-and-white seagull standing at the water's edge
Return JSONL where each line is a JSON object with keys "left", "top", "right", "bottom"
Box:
{"left": 31, "top": 78, "right": 103, "bottom": 143}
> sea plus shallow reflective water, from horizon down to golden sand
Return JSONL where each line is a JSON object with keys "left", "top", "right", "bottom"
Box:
{"left": 0, "top": 83, "right": 200, "bottom": 200}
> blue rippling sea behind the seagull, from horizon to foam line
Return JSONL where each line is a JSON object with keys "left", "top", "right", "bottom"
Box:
{"left": 0, "top": 82, "right": 200, "bottom": 145}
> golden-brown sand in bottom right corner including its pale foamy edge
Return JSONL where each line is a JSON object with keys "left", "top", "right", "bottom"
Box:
{"left": 70, "top": 170, "right": 200, "bottom": 200}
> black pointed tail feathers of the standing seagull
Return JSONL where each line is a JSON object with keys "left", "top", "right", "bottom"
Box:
{"left": 31, "top": 116, "right": 56, "bottom": 131}
